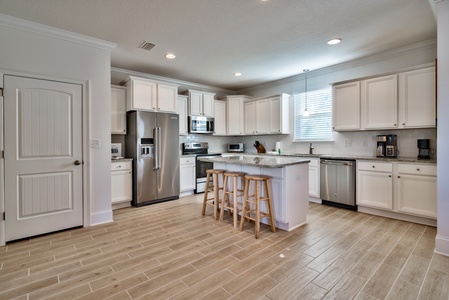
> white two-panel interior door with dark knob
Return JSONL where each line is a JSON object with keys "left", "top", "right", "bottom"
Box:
{"left": 4, "top": 75, "right": 83, "bottom": 241}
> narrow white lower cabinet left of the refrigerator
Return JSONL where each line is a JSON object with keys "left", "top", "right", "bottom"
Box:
{"left": 111, "top": 161, "right": 133, "bottom": 204}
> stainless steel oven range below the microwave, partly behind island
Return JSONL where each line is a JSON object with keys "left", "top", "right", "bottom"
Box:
{"left": 182, "top": 143, "right": 221, "bottom": 194}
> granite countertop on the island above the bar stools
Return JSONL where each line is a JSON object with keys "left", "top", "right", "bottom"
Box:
{"left": 198, "top": 154, "right": 310, "bottom": 168}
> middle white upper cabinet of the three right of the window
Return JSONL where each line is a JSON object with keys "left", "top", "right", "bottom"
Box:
{"left": 361, "top": 74, "right": 398, "bottom": 129}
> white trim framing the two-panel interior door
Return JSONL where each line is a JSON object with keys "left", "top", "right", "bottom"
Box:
{"left": 0, "top": 69, "right": 90, "bottom": 247}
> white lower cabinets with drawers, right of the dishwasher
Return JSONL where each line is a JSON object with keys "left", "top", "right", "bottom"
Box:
{"left": 357, "top": 161, "right": 437, "bottom": 219}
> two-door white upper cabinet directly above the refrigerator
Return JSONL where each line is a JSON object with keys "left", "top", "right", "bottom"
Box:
{"left": 126, "top": 76, "right": 178, "bottom": 112}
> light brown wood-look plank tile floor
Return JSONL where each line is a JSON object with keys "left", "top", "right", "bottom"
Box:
{"left": 0, "top": 195, "right": 449, "bottom": 300}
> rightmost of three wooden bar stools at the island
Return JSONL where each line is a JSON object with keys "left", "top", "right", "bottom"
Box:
{"left": 240, "top": 175, "right": 276, "bottom": 239}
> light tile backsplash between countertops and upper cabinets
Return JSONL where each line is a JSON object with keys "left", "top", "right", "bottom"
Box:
{"left": 179, "top": 129, "right": 436, "bottom": 157}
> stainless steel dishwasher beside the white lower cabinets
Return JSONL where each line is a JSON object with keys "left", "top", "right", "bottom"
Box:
{"left": 320, "top": 159, "right": 357, "bottom": 210}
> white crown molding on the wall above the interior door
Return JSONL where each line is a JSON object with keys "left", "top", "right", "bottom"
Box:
{"left": 0, "top": 14, "right": 117, "bottom": 51}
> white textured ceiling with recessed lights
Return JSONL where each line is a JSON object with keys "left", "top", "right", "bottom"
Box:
{"left": 0, "top": 0, "right": 437, "bottom": 91}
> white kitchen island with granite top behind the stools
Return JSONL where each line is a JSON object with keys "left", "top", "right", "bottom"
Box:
{"left": 201, "top": 155, "right": 310, "bottom": 231}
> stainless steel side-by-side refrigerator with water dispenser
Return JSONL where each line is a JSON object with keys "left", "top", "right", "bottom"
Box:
{"left": 125, "top": 111, "right": 179, "bottom": 206}
